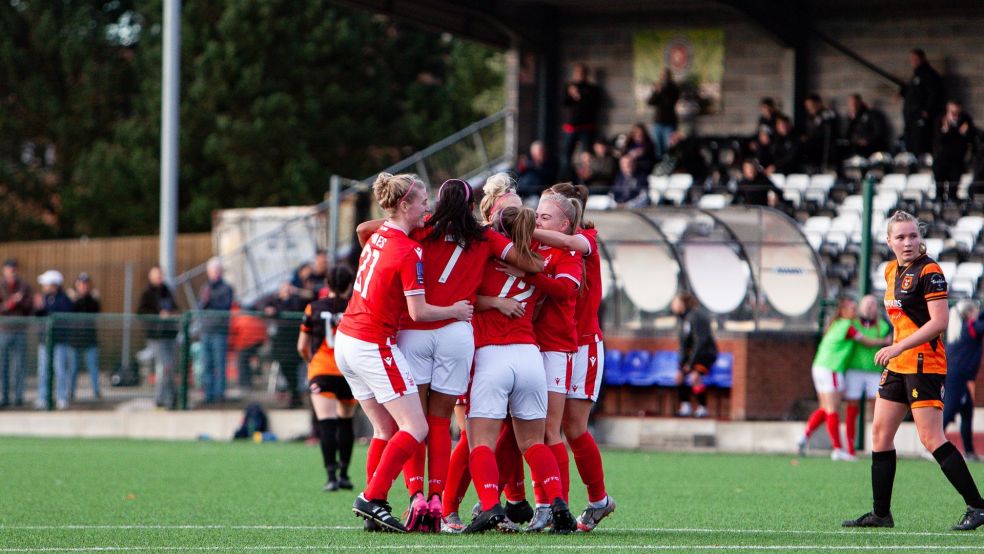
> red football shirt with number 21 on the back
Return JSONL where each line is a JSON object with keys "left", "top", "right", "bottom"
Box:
{"left": 338, "top": 222, "right": 424, "bottom": 344}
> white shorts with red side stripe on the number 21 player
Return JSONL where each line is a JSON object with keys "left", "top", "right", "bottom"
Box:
{"left": 335, "top": 331, "right": 417, "bottom": 404}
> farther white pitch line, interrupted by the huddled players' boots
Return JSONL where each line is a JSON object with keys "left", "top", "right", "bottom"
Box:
{"left": 0, "top": 524, "right": 978, "bottom": 536}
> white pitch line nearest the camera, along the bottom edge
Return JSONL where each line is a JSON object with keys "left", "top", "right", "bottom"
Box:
{"left": 0, "top": 544, "right": 981, "bottom": 552}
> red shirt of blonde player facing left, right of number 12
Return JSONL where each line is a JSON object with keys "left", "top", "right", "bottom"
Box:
{"left": 536, "top": 245, "right": 583, "bottom": 352}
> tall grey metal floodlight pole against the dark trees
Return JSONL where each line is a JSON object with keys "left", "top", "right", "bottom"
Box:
{"left": 159, "top": 0, "right": 181, "bottom": 283}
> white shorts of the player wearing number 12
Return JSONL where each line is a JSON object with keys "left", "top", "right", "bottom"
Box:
{"left": 468, "top": 344, "right": 547, "bottom": 419}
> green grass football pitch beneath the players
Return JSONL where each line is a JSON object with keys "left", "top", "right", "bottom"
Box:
{"left": 0, "top": 438, "right": 984, "bottom": 553}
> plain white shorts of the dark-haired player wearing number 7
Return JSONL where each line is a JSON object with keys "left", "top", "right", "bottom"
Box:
{"left": 396, "top": 321, "right": 475, "bottom": 396}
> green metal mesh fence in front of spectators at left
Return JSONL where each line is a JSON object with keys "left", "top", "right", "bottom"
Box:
{"left": 0, "top": 311, "right": 306, "bottom": 410}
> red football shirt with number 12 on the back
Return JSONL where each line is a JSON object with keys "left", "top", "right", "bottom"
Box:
{"left": 472, "top": 260, "right": 540, "bottom": 348}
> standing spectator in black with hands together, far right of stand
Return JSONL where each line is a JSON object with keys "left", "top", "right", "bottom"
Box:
{"left": 933, "top": 100, "right": 977, "bottom": 201}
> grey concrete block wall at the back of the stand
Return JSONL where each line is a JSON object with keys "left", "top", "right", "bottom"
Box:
{"left": 544, "top": 7, "right": 984, "bottom": 148}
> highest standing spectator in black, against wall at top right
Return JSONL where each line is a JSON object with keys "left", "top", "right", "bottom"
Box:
{"left": 900, "top": 48, "right": 943, "bottom": 156}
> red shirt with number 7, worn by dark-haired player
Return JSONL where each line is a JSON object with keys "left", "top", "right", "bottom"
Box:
{"left": 400, "top": 227, "right": 513, "bottom": 329}
